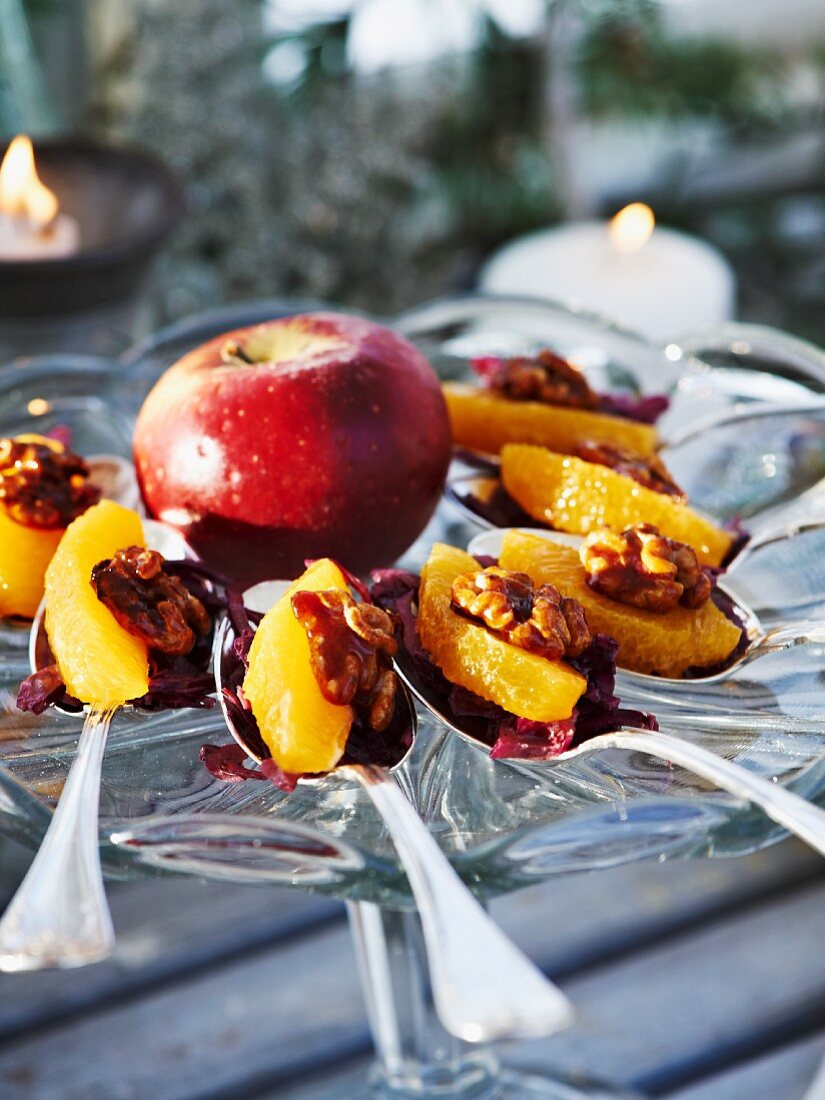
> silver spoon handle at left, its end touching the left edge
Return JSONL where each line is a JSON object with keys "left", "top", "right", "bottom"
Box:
{"left": 0, "top": 711, "right": 114, "bottom": 970}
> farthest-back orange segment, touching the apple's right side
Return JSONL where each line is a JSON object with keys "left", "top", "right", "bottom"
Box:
{"left": 442, "top": 382, "right": 659, "bottom": 454}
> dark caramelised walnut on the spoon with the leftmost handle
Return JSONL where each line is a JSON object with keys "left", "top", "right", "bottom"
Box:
{"left": 91, "top": 547, "right": 212, "bottom": 657}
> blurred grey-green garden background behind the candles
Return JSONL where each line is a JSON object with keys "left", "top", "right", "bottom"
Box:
{"left": 0, "top": 0, "right": 825, "bottom": 341}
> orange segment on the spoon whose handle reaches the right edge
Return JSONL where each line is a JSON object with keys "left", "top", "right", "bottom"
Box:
{"left": 418, "top": 542, "right": 587, "bottom": 722}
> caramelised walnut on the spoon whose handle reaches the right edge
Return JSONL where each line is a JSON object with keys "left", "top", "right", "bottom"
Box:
{"left": 452, "top": 565, "right": 593, "bottom": 660}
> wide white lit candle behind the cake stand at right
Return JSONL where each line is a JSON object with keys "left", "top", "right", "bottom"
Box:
{"left": 480, "top": 202, "right": 736, "bottom": 341}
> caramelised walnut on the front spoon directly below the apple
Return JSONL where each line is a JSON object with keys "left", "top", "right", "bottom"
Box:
{"left": 292, "top": 589, "right": 398, "bottom": 733}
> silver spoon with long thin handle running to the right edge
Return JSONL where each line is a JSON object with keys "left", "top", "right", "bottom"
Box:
{"left": 396, "top": 652, "right": 825, "bottom": 855}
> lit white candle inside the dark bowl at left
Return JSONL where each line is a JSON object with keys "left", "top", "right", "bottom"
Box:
{"left": 0, "top": 134, "right": 80, "bottom": 262}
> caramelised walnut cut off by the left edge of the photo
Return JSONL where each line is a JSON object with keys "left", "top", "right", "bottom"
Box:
{"left": 0, "top": 437, "right": 100, "bottom": 529}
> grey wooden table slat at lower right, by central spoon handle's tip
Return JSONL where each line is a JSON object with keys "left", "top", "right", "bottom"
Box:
{"left": 503, "top": 883, "right": 825, "bottom": 1092}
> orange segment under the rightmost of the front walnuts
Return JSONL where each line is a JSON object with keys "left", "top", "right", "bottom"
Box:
{"left": 499, "top": 530, "right": 739, "bottom": 677}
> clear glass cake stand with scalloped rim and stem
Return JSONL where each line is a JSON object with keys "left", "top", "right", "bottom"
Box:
{"left": 0, "top": 297, "right": 825, "bottom": 1100}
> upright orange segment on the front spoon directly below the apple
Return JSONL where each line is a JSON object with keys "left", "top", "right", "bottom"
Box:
{"left": 243, "top": 558, "right": 353, "bottom": 773}
